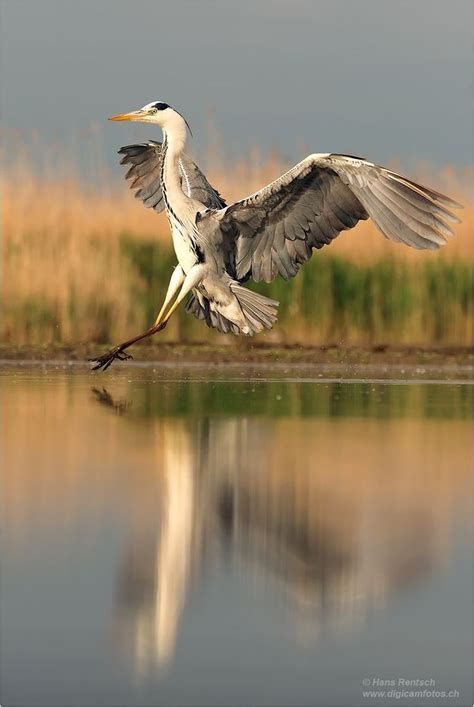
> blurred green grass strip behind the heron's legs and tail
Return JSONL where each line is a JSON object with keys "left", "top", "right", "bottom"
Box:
{"left": 117, "top": 236, "right": 474, "bottom": 344}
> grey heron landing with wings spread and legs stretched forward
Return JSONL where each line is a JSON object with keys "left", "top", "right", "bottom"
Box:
{"left": 93, "top": 101, "right": 461, "bottom": 370}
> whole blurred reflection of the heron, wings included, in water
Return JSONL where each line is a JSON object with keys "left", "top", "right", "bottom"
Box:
{"left": 92, "top": 396, "right": 440, "bottom": 670}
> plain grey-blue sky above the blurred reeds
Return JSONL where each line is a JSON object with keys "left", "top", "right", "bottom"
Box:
{"left": 0, "top": 0, "right": 474, "bottom": 166}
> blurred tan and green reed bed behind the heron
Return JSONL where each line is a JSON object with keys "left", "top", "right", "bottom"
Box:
{"left": 0, "top": 131, "right": 474, "bottom": 345}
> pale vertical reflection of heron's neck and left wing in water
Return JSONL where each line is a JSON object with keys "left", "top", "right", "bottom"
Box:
{"left": 119, "top": 425, "right": 195, "bottom": 668}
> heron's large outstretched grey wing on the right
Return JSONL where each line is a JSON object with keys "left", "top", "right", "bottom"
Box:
{"left": 217, "top": 154, "right": 461, "bottom": 282}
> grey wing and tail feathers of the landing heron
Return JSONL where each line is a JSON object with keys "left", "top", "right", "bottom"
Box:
{"left": 119, "top": 131, "right": 460, "bottom": 335}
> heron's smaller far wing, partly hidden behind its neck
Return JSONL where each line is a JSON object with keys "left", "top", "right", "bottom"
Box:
{"left": 115, "top": 140, "right": 226, "bottom": 213}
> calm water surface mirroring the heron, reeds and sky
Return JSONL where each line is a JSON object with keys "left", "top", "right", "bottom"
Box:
{"left": 0, "top": 366, "right": 473, "bottom": 707}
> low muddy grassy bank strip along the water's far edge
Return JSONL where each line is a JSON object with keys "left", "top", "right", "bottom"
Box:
{"left": 0, "top": 338, "right": 474, "bottom": 380}
